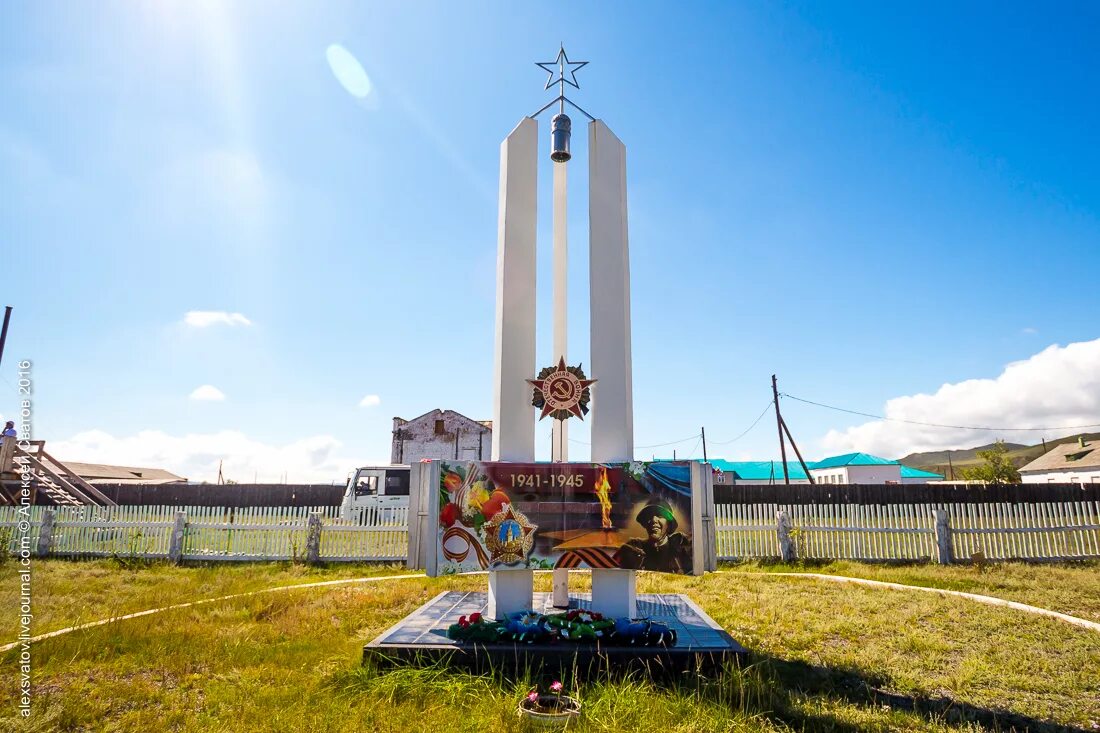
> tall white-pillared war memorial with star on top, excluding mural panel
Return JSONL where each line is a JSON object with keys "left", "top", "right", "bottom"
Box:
{"left": 490, "top": 48, "right": 635, "bottom": 616}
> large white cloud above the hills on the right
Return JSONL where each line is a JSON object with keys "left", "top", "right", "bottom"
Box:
{"left": 822, "top": 339, "right": 1100, "bottom": 458}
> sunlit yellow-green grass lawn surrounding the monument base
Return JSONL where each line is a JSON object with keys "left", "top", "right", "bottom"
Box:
{"left": 0, "top": 560, "right": 1100, "bottom": 733}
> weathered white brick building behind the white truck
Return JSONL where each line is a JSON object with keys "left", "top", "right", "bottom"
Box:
{"left": 389, "top": 409, "right": 493, "bottom": 463}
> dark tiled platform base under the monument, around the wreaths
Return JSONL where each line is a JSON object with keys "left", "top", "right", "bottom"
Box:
{"left": 363, "top": 591, "right": 748, "bottom": 675}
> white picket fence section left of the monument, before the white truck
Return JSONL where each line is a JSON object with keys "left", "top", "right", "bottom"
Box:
{"left": 0, "top": 506, "right": 408, "bottom": 562}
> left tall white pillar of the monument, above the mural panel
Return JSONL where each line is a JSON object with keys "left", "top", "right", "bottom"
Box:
{"left": 491, "top": 118, "right": 538, "bottom": 460}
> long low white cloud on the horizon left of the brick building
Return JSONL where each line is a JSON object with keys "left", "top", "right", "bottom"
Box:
{"left": 51, "top": 430, "right": 365, "bottom": 483}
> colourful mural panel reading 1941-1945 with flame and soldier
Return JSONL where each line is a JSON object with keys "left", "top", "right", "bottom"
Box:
{"left": 436, "top": 461, "right": 693, "bottom": 575}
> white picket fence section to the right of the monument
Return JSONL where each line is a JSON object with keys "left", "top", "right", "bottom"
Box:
{"left": 715, "top": 502, "right": 1100, "bottom": 562}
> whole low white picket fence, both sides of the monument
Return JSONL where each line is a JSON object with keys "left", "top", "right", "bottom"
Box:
{"left": 0, "top": 501, "right": 1100, "bottom": 562}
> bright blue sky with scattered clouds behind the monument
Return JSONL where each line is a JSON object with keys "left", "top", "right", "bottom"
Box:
{"left": 0, "top": 0, "right": 1100, "bottom": 480}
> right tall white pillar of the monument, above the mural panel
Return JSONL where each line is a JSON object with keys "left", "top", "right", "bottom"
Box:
{"left": 589, "top": 120, "right": 634, "bottom": 462}
